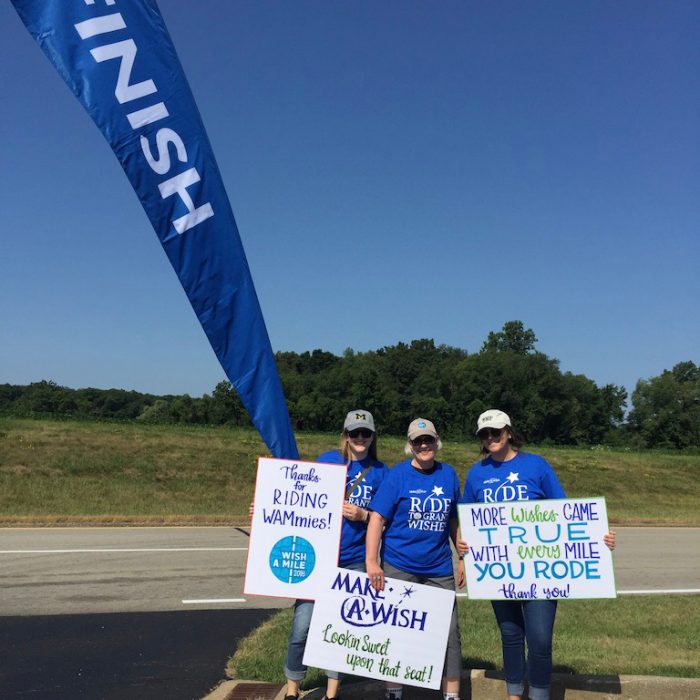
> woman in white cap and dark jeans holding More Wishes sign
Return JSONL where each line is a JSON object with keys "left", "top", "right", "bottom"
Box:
{"left": 460, "top": 409, "right": 615, "bottom": 700}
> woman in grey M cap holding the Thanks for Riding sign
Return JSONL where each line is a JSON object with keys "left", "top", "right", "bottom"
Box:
{"left": 284, "top": 409, "right": 389, "bottom": 700}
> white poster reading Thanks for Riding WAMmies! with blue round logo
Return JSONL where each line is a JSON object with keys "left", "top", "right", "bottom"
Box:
{"left": 243, "top": 457, "right": 347, "bottom": 600}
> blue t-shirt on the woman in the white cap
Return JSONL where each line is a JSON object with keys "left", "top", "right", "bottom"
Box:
{"left": 462, "top": 452, "right": 566, "bottom": 503}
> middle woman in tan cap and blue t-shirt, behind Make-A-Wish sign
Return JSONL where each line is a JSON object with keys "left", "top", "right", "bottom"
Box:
{"left": 366, "top": 418, "right": 462, "bottom": 700}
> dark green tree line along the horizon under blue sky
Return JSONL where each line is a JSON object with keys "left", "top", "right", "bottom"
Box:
{"left": 0, "top": 321, "right": 700, "bottom": 449}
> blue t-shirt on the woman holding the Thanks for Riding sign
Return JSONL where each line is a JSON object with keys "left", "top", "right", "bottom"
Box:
{"left": 316, "top": 450, "right": 389, "bottom": 566}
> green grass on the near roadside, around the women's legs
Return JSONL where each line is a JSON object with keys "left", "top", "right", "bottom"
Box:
{"left": 227, "top": 596, "right": 700, "bottom": 689}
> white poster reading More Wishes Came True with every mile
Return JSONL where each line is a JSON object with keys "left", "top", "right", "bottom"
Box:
{"left": 458, "top": 498, "right": 617, "bottom": 600}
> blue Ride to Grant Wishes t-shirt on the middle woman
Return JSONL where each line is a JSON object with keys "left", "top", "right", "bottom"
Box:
{"left": 372, "top": 460, "right": 459, "bottom": 577}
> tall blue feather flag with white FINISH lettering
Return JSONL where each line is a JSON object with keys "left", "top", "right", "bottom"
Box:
{"left": 12, "top": 0, "right": 298, "bottom": 459}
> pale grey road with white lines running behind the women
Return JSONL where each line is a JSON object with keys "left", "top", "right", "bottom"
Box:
{"left": 0, "top": 527, "right": 700, "bottom": 615}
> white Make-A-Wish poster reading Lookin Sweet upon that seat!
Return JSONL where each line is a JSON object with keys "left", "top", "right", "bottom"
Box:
{"left": 304, "top": 569, "right": 455, "bottom": 689}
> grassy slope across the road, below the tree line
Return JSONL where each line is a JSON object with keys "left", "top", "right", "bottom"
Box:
{"left": 0, "top": 418, "right": 700, "bottom": 525}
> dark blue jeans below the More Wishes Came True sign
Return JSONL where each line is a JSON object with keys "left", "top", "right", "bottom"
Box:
{"left": 491, "top": 600, "right": 557, "bottom": 700}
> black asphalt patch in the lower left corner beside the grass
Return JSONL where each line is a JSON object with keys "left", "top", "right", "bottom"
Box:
{"left": 0, "top": 609, "right": 274, "bottom": 700}
